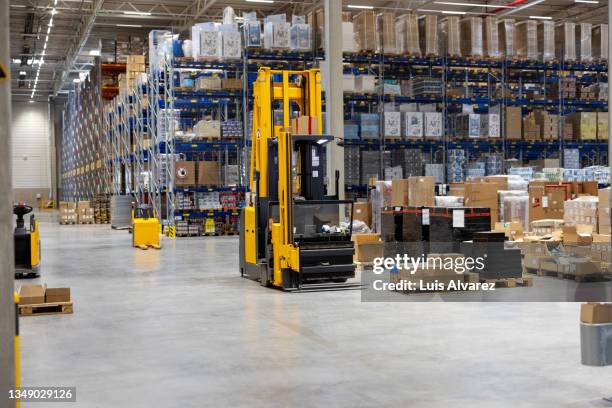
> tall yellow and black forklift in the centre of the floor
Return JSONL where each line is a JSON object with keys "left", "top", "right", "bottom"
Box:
{"left": 239, "top": 68, "right": 359, "bottom": 291}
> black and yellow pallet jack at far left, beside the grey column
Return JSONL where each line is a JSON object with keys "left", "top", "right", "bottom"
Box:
{"left": 13, "top": 203, "right": 40, "bottom": 278}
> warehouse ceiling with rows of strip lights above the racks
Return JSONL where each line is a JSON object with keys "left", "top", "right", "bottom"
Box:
{"left": 10, "top": 0, "right": 608, "bottom": 100}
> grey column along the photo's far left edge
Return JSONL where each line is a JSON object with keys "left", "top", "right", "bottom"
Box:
{"left": 0, "top": 0, "right": 15, "bottom": 407}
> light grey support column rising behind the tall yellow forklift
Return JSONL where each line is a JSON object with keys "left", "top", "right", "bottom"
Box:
{"left": 322, "top": 0, "right": 344, "bottom": 199}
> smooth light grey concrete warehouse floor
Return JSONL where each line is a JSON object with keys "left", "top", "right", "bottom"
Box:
{"left": 20, "top": 222, "right": 612, "bottom": 408}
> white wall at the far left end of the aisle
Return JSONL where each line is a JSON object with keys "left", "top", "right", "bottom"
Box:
{"left": 11, "top": 102, "right": 52, "bottom": 206}
